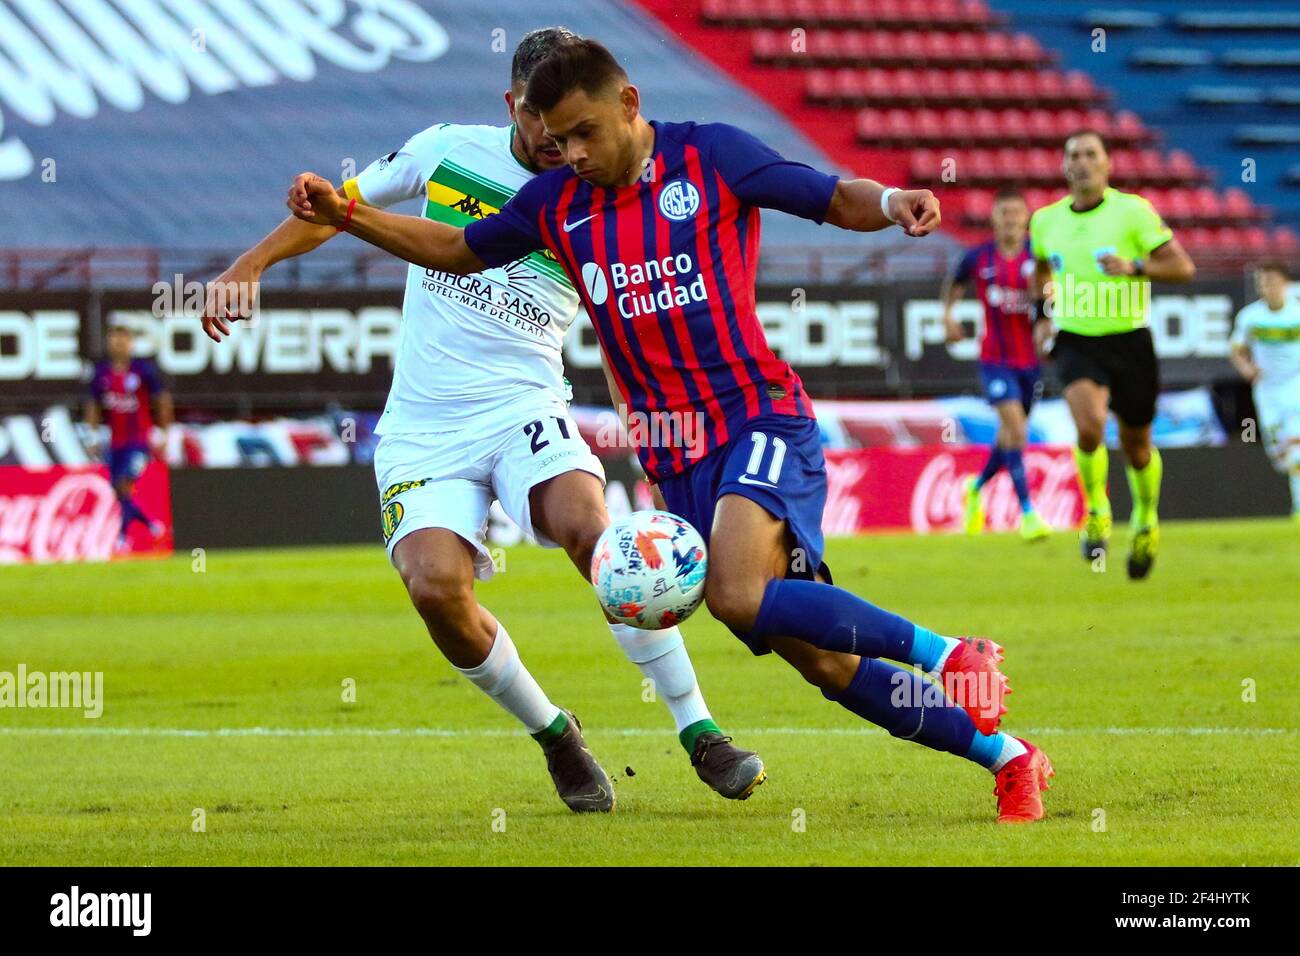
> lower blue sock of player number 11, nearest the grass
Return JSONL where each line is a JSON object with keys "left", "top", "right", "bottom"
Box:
{"left": 823, "top": 657, "right": 982, "bottom": 757}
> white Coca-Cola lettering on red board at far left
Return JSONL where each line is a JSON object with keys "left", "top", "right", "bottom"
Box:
{"left": 0, "top": 472, "right": 120, "bottom": 563}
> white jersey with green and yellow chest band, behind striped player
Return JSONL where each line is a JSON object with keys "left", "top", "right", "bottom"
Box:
{"left": 343, "top": 124, "right": 579, "bottom": 434}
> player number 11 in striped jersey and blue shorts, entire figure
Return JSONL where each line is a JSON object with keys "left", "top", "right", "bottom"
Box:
{"left": 289, "top": 39, "right": 1052, "bottom": 823}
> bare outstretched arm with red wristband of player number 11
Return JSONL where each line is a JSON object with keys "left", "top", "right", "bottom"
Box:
{"left": 287, "top": 173, "right": 488, "bottom": 276}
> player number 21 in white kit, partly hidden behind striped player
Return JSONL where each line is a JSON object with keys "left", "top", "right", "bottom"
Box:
{"left": 204, "top": 27, "right": 766, "bottom": 812}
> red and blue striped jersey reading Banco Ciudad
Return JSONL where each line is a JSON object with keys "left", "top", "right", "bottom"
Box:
{"left": 465, "top": 122, "right": 837, "bottom": 480}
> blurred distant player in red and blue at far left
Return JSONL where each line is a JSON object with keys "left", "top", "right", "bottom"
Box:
{"left": 82, "top": 325, "right": 173, "bottom": 551}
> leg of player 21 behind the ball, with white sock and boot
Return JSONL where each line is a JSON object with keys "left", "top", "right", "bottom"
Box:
{"left": 529, "top": 471, "right": 767, "bottom": 800}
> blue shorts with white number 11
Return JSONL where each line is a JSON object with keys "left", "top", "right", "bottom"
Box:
{"left": 659, "top": 415, "right": 831, "bottom": 654}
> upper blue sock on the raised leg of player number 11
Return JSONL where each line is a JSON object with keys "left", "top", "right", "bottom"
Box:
{"left": 750, "top": 578, "right": 948, "bottom": 671}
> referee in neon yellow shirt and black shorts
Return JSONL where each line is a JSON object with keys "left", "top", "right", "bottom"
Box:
{"left": 1030, "top": 130, "right": 1196, "bottom": 580}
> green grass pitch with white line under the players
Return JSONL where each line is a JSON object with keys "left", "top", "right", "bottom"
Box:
{"left": 0, "top": 520, "right": 1300, "bottom": 866}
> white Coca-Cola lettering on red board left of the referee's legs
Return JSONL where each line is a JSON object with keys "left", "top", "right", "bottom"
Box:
{"left": 911, "top": 451, "right": 1082, "bottom": 532}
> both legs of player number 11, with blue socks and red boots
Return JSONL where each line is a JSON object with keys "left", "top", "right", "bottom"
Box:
{"left": 705, "top": 494, "right": 1050, "bottom": 822}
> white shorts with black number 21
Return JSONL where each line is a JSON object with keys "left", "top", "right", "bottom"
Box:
{"left": 374, "top": 397, "right": 605, "bottom": 580}
